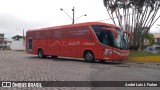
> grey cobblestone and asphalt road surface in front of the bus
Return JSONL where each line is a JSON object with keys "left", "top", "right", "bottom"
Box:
{"left": 0, "top": 50, "right": 160, "bottom": 90}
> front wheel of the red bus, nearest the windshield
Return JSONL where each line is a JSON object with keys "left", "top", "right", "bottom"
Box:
{"left": 84, "top": 51, "right": 95, "bottom": 63}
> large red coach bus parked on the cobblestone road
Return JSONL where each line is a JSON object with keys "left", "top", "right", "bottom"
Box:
{"left": 26, "top": 22, "right": 131, "bottom": 62}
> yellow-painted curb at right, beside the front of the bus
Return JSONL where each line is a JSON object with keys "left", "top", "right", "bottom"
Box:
{"left": 127, "top": 56, "right": 160, "bottom": 62}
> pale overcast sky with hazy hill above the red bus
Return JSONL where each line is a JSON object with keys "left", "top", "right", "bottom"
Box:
{"left": 0, "top": 0, "right": 160, "bottom": 37}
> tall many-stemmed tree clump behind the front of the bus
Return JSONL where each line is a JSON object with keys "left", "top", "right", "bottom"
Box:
{"left": 103, "top": 0, "right": 160, "bottom": 49}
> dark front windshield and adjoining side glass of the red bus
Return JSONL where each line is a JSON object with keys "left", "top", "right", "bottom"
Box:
{"left": 92, "top": 25, "right": 128, "bottom": 50}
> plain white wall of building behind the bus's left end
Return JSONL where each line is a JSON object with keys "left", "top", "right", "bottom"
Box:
{"left": 10, "top": 39, "right": 25, "bottom": 50}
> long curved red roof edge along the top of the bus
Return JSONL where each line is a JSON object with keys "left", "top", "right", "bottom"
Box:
{"left": 28, "top": 22, "right": 119, "bottom": 31}
